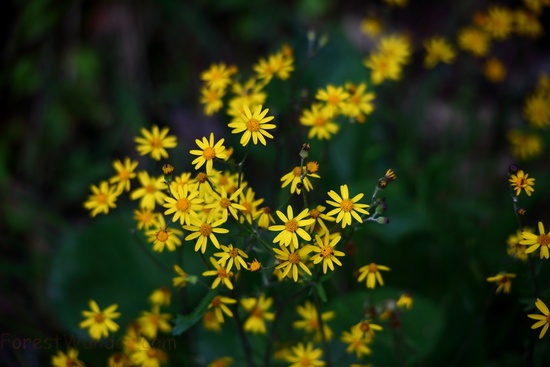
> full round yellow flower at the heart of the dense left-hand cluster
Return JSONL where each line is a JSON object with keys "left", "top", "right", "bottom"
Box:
{"left": 164, "top": 185, "right": 203, "bottom": 225}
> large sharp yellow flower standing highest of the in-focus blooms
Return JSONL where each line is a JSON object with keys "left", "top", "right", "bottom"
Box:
{"left": 228, "top": 105, "right": 276, "bottom": 146}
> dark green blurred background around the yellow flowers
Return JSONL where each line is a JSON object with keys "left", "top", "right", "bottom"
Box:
{"left": 0, "top": 0, "right": 550, "bottom": 366}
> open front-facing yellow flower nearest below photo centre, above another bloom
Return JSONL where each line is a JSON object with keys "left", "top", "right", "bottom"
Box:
{"left": 268, "top": 205, "right": 315, "bottom": 249}
